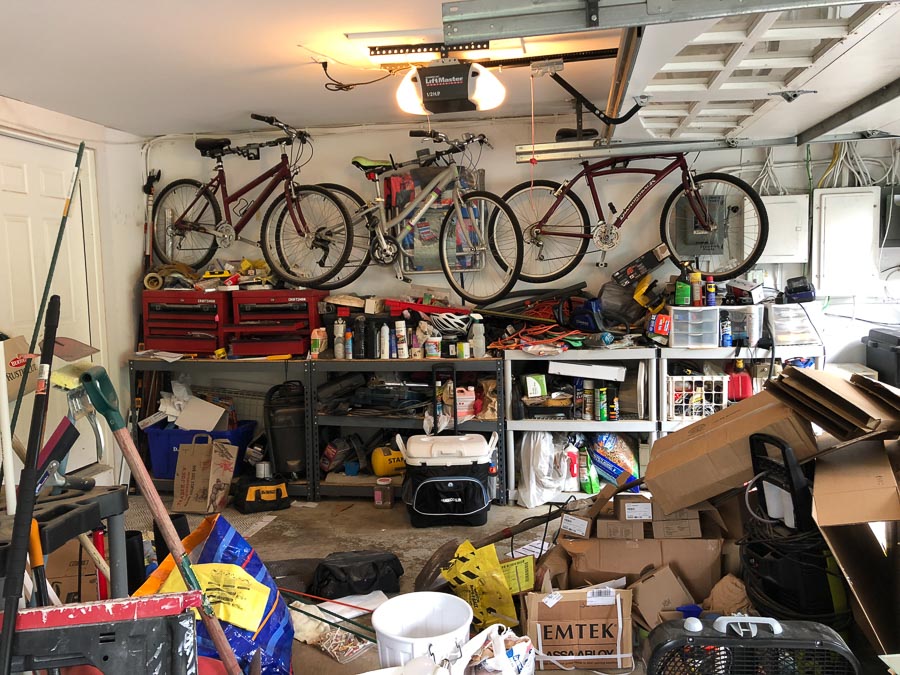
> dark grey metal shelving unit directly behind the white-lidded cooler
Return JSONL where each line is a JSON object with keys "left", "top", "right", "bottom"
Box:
{"left": 308, "top": 359, "right": 507, "bottom": 504}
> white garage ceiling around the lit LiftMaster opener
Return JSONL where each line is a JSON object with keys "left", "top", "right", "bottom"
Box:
{"left": 0, "top": 0, "right": 620, "bottom": 136}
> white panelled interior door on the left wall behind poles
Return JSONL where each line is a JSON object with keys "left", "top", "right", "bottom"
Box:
{"left": 0, "top": 135, "right": 97, "bottom": 471}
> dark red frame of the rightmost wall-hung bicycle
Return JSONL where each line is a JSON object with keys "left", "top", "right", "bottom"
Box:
{"left": 534, "top": 153, "right": 704, "bottom": 239}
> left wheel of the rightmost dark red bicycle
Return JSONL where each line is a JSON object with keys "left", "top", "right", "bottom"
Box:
{"left": 503, "top": 180, "right": 591, "bottom": 284}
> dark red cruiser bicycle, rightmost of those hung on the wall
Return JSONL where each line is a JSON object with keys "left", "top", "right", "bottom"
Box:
{"left": 503, "top": 105, "right": 769, "bottom": 283}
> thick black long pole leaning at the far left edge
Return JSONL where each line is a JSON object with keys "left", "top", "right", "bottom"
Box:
{"left": 0, "top": 295, "right": 59, "bottom": 675}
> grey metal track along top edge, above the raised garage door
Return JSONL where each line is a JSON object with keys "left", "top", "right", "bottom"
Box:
{"left": 442, "top": 0, "right": 884, "bottom": 45}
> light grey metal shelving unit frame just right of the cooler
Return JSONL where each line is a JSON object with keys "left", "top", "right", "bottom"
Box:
{"left": 503, "top": 347, "right": 659, "bottom": 500}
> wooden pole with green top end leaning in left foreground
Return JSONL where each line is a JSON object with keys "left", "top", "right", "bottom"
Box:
{"left": 81, "top": 366, "right": 241, "bottom": 675}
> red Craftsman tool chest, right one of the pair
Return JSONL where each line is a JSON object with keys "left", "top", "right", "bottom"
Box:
{"left": 225, "top": 289, "right": 328, "bottom": 356}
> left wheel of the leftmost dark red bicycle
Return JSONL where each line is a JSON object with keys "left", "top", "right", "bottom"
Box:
{"left": 153, "top": 178, "right": 222, "bottom": 269}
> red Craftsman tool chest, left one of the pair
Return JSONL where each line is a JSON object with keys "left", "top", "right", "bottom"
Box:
{"left": 142, "top": 290, "right": 231, "bottom": 354}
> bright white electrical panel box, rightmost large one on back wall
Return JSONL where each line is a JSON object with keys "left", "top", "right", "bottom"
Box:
{"left": 812, "top": 187, "right": 881, "bottom": 296}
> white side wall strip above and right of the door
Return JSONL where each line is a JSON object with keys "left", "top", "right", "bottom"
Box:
{"left": 0, "top": 97, "right": 144, "bottom": 454}
